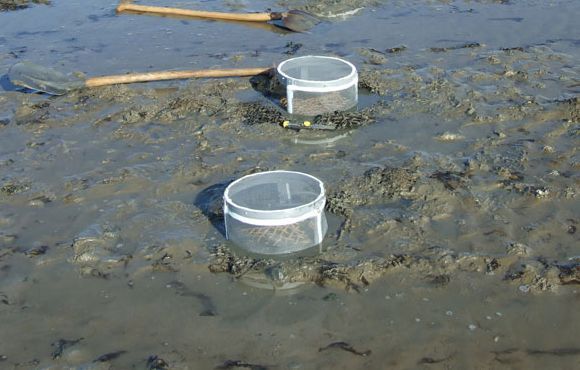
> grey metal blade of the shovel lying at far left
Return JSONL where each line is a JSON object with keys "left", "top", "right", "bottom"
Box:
{"left": 8, "top": 62, "right": 84, "bottom": 95}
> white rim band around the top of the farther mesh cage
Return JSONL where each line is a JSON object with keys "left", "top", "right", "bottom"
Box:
{"left": 276, "top": 55, "right": 358, "bottom": 92}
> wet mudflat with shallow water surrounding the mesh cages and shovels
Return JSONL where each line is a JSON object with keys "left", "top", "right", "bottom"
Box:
{"left": 0, "top": 0, "right": 580, "bottom": 369}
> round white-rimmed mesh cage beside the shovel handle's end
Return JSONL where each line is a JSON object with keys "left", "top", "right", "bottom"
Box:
{"left": 277, "top": 55, "right": 358, "bottom": 116}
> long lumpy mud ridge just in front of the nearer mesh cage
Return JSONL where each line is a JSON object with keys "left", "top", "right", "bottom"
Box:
{"left": 209, "top": 247, "right": 580, "bottom": 293}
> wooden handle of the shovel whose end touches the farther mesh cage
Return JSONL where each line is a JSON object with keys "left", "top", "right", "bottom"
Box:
{"left": 85, "top": 67, "right": 272, "bottom": 87}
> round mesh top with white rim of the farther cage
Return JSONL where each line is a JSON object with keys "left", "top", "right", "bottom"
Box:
{"left": 277, "top": 55, "right": 357, "bottom": 87}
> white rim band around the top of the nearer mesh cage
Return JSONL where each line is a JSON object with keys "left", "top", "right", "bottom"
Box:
{"left": 224, "top": 170, "right": 326, "bottom": 226}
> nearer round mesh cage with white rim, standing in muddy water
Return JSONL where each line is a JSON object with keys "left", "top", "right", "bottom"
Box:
{"left": 224, "top": 171, "right": 328, "bottom": 255}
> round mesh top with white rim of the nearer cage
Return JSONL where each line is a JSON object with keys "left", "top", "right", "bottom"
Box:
{"left": 224, "top": 170, "right": 326, "bottom": 220}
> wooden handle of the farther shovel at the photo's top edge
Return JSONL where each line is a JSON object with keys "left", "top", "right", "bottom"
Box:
{"left": 117, "top": 3, "right": 278, "bottom": 22}
